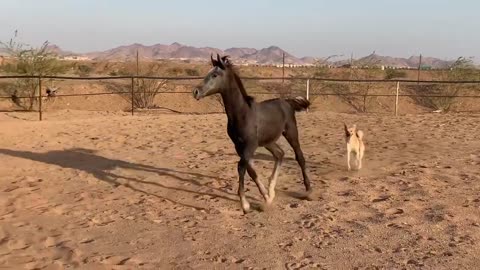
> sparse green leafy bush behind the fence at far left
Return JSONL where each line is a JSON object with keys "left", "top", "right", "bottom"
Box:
{"left": 0, "top": 31, "right": 64, "bottom": 110}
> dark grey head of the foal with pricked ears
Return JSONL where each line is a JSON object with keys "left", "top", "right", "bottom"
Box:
{"left": 193, "top": 54, "right": 232, "bottom": 100}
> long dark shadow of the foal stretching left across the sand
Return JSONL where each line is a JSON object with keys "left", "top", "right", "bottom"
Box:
{"left": 0, "top": 148, "right": 244, "bottom": 210}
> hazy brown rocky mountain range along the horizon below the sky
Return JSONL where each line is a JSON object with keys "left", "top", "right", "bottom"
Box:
{"left": 0, "top": 42, "right": 462, "bottom": 69}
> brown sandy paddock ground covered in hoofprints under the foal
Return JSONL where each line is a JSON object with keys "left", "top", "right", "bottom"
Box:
{"left": 0, "top": 112, "right": 480, "bottom": 269}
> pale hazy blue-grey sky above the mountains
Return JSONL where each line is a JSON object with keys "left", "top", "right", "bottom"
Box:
{"left": 0, "top": 0, "right": 480, "bottom": 61}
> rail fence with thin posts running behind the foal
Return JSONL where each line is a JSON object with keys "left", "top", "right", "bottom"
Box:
{"left": 0, "top": 75, "right": 480, "bottom": 120}
